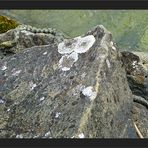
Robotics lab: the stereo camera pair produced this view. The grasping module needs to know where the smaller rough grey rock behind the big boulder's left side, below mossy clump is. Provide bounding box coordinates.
[0,25,64,59]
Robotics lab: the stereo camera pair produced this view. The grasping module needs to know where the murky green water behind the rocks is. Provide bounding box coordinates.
[1,10,148,51]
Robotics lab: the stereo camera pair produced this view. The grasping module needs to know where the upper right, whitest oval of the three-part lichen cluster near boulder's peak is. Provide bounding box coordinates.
[74,35,96,53]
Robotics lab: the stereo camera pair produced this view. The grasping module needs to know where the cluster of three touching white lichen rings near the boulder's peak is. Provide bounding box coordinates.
[58,35,96,71]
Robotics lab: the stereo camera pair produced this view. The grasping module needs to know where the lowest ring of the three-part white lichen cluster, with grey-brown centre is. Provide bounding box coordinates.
[59,52,78,71]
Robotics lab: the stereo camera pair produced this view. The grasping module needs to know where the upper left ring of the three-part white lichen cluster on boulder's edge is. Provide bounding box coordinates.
[58,39,77,54]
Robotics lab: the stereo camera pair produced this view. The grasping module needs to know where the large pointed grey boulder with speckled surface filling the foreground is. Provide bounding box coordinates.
[0,25,137,138]
